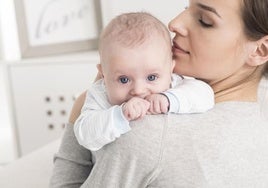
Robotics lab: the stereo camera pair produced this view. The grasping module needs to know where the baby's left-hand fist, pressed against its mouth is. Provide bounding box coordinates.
[123,97,150,121]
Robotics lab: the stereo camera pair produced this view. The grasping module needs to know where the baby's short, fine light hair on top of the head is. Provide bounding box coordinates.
[99,12,171,53]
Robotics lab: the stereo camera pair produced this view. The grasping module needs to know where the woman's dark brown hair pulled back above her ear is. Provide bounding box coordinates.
[242,0,268,75]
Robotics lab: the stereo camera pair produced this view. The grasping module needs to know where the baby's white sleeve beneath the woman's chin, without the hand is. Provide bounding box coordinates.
[163,78,215,113]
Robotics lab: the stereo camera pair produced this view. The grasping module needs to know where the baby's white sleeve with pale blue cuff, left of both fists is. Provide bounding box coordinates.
[74,85,130,151]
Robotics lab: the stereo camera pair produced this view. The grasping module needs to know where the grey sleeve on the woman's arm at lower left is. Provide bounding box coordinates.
[49,124,93,188]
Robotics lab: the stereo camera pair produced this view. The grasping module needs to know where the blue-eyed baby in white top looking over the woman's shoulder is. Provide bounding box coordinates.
[74,12,214,151]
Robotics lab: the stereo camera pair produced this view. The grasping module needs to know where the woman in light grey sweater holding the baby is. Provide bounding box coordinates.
[51,0,268,188]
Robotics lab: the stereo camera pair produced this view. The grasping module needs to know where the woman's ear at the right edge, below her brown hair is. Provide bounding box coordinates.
[248,35,268,66]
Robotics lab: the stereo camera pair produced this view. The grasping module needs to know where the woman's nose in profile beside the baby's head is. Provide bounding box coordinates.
[168,10,188,36]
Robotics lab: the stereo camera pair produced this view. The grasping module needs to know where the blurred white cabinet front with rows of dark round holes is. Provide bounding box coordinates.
[9,62,97,155]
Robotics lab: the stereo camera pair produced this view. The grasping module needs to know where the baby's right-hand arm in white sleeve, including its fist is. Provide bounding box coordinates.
[146,77,214,114]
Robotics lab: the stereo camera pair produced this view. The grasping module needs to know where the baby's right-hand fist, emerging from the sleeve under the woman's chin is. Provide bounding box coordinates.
[145,94,169,114]
